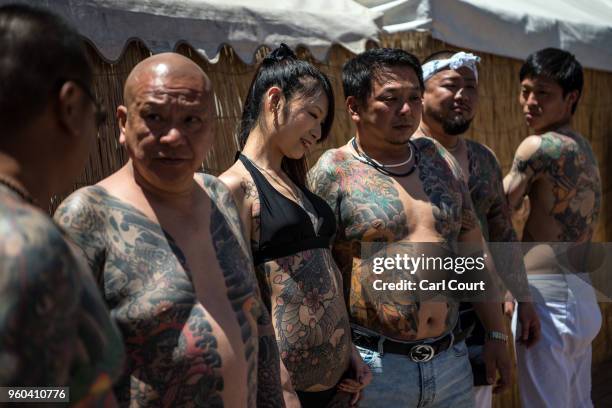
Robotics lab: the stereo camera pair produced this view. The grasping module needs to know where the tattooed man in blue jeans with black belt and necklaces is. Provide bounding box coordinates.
[310,49,510,407]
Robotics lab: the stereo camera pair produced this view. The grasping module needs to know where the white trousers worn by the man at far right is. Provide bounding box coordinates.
[512,274,601,408]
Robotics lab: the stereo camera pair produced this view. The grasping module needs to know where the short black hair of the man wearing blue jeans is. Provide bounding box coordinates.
[342,48,424,103]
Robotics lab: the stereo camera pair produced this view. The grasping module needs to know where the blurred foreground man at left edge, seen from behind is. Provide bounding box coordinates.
[0,6,123,406]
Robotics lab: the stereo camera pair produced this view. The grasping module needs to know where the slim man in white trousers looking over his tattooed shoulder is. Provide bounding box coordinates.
[504,48,601,408]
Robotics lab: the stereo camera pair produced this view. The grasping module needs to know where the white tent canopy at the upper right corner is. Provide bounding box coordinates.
[358,0,612,71]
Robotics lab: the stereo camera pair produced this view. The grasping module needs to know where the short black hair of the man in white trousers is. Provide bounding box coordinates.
[519,48,584,114]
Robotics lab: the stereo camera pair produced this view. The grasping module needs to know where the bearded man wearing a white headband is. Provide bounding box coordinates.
[416,51,540,408]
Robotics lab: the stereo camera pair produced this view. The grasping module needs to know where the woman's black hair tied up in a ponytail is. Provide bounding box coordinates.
[238,44,335,186]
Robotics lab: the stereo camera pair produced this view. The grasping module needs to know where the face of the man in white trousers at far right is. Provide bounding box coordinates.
[519,77,579,135]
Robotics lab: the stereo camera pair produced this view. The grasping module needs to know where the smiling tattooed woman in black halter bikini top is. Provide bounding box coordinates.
[220,44,371,408]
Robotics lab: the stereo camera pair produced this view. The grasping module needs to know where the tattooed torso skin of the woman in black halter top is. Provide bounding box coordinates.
[242,175,351,391]
